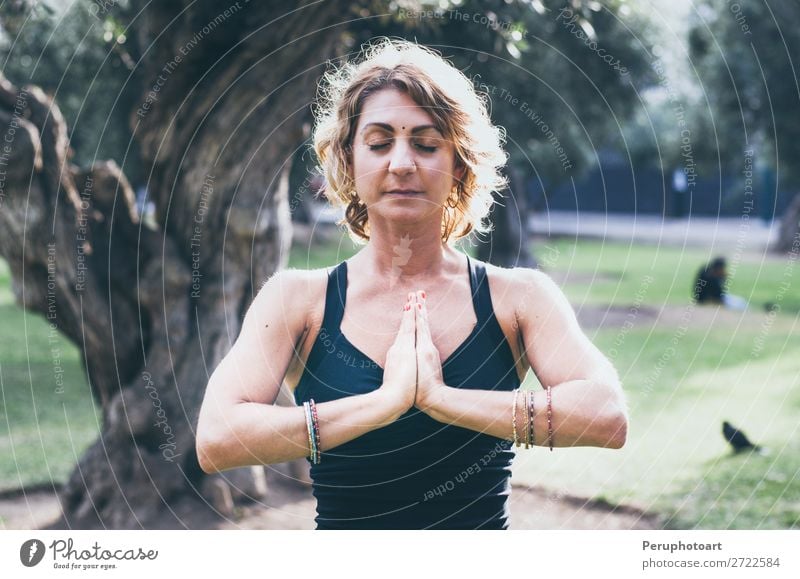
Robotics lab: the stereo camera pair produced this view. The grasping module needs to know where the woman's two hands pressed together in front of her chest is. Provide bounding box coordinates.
[381,291,446,411]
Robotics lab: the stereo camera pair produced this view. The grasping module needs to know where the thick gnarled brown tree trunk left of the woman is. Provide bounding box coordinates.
[0,0,346,529]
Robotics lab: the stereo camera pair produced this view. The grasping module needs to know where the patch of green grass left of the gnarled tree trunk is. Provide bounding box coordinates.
[0,260,100,490]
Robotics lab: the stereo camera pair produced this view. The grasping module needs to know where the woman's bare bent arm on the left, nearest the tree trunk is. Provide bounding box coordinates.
[197,271,414,473]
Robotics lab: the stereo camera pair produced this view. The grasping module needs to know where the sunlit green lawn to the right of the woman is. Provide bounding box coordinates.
[514,241,800,529]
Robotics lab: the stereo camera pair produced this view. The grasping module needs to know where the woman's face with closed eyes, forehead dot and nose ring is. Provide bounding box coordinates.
[351,89,463,223]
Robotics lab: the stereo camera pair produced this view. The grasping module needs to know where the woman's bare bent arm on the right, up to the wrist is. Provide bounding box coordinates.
[417,270,628,448]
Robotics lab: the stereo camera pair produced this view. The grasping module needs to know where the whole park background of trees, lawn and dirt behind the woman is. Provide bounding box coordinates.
[0,0,800,529]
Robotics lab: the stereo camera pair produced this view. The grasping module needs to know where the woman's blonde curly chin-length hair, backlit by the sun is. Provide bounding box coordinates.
[314,38,507,244]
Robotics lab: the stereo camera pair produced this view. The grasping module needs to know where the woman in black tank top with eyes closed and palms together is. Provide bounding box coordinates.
[197,41,627,529]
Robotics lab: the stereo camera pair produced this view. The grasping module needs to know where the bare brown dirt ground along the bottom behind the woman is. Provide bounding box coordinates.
[0,481,661,530]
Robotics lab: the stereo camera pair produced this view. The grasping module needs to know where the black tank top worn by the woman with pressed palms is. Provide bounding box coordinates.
[294,256,520,529]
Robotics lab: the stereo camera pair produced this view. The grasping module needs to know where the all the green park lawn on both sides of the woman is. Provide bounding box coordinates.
[0,232,800,529]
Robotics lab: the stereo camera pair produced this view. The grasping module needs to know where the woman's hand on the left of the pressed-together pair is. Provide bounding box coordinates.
[380,293,417,417]
